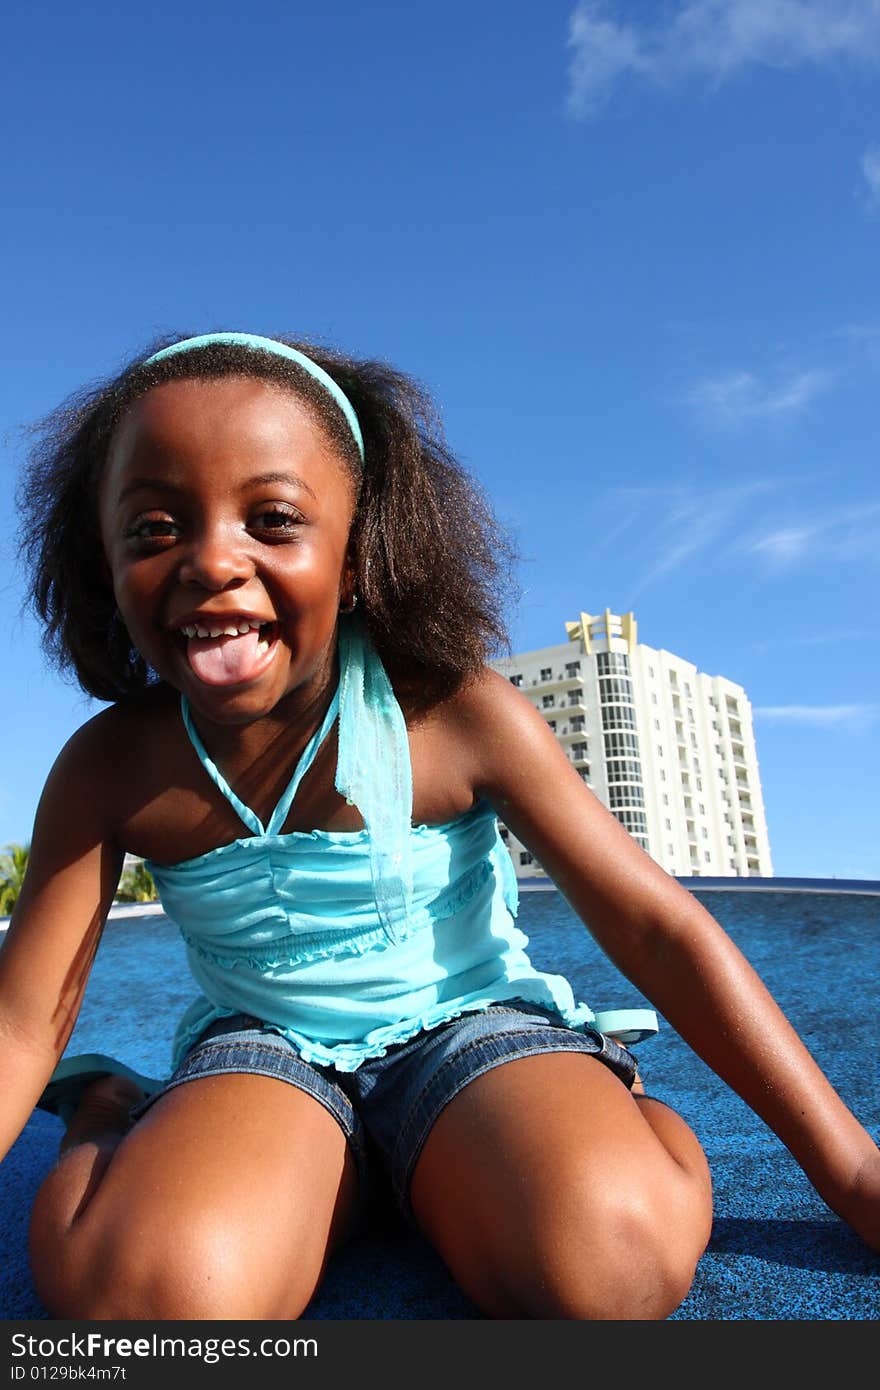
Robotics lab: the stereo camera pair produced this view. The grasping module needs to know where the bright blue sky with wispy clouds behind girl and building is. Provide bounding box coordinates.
[0,0,880,878]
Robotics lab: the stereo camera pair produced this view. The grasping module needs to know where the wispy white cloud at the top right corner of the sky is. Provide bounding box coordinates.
[569,0,880,117]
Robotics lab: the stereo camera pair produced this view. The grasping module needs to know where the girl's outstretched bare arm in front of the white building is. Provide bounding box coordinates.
[459,673,880,1250]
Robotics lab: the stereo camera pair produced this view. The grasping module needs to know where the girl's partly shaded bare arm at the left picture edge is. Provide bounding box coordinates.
[0,714,124,1158]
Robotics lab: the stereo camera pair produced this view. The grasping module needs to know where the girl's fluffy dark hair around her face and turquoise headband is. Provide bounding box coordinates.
[18,334,514,709]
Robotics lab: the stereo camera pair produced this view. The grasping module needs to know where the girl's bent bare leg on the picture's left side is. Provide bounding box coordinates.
[31,1073,357,1319]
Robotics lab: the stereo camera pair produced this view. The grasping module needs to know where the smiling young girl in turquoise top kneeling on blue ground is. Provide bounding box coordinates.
[0,334,880,1319]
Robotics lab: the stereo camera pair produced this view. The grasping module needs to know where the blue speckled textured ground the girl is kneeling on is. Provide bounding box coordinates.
[0,890,880,1321]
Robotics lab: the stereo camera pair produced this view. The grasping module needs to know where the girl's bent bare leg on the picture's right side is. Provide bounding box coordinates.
[410,1052,712,1319]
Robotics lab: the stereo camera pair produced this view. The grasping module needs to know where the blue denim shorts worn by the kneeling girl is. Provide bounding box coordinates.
[133,1001,635,1219]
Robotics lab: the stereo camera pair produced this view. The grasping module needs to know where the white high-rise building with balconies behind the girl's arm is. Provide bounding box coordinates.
[492,609,773,877]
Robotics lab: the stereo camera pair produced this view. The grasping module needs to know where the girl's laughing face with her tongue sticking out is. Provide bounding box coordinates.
[100,377,355,724]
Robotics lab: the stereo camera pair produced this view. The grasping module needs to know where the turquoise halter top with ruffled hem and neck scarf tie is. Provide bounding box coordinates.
[149,621,647,1072]
